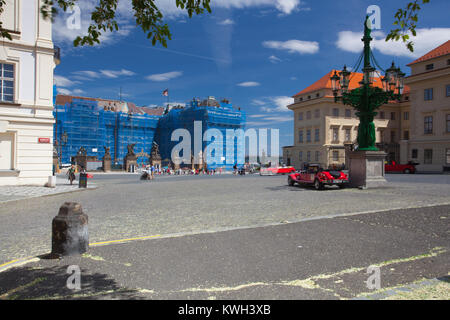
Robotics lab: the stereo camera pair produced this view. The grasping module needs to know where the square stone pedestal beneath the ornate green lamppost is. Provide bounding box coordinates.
[349,150,387,189]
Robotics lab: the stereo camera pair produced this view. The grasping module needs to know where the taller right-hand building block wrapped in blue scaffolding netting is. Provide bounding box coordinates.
[156,97,246,170]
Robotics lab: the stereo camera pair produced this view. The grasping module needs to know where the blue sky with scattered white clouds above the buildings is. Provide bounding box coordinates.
[53,0,450,146]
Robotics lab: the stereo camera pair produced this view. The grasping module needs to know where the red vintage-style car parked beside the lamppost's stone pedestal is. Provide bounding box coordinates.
[288,165,349,190]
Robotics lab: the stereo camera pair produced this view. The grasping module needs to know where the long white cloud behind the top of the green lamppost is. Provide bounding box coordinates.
[336,28,450,58]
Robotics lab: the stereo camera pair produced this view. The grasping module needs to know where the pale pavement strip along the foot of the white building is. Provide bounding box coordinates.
[0,178,95,203]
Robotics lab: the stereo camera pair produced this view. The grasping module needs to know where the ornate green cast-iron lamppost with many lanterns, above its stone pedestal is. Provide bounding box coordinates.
[330,16,405,151]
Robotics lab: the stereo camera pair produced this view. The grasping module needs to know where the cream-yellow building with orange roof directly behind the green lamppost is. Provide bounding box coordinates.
[283,70,410,169]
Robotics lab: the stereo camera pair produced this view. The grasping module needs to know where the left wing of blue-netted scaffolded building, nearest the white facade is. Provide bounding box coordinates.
[54,95,164,164]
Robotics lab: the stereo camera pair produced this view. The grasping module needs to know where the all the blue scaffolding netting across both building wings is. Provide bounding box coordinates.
[54,97,250,170]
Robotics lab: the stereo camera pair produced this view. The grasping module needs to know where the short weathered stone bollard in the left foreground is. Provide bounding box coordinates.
[51,202,89,256]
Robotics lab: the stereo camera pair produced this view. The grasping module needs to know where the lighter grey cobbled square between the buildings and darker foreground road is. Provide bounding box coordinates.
[0,174,450,264]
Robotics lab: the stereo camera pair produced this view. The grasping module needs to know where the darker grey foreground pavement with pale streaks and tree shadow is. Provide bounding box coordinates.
[0,205,450,301]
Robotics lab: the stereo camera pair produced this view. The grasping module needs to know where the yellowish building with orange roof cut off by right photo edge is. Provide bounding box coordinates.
[405,40,450,172]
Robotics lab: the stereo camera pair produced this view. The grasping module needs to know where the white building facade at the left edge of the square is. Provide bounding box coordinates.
[0,0,56,185]
